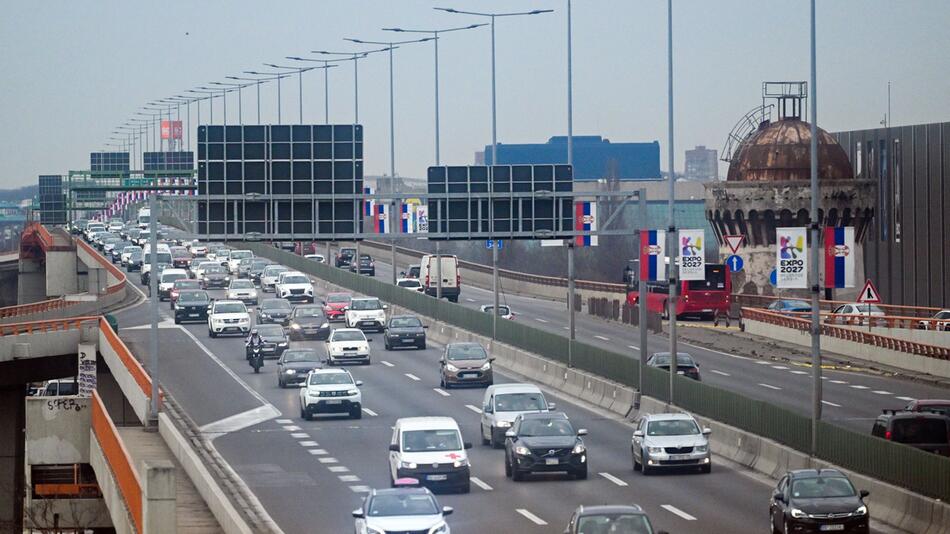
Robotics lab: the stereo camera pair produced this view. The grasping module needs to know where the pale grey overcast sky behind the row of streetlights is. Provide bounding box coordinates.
[0,0,950,188]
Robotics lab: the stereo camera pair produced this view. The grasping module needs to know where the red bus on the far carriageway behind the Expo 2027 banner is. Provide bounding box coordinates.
[624,263,732,319]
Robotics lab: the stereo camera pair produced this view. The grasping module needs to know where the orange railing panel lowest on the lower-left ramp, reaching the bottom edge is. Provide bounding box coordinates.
[92,391,142,532]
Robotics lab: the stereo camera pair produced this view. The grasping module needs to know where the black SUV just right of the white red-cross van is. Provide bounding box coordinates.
[505,412,587,481]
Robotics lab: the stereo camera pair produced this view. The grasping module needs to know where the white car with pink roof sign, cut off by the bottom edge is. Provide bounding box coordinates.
[353,484,453,534]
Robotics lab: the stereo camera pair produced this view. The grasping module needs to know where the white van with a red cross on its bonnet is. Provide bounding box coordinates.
[389,417,472,493]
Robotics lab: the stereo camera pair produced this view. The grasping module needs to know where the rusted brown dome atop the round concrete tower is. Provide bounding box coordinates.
[726,118,854,182]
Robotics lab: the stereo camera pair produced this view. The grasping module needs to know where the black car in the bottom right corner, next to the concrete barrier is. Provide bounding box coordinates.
[769,469,870,534]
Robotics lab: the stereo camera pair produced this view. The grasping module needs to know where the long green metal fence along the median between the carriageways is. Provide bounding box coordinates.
[246,243,950,500]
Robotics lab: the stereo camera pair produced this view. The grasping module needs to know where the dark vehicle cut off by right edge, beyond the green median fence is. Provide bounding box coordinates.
[871,410,950,456]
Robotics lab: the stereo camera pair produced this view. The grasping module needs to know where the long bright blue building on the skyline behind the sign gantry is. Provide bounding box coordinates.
[475,135,660,181]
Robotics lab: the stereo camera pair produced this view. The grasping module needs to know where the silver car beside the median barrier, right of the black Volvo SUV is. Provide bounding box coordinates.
[630,413,712,475]
